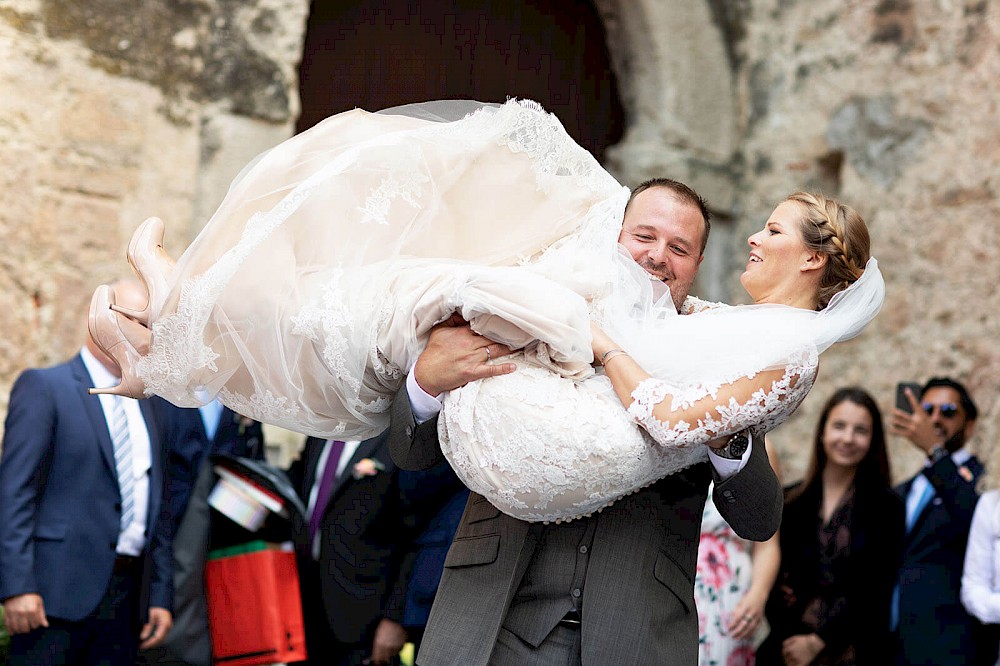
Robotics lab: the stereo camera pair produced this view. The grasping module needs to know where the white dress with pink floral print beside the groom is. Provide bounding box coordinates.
[694,482,754,666]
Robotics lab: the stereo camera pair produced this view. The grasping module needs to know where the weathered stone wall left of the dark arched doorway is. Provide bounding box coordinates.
[0,0,308,462]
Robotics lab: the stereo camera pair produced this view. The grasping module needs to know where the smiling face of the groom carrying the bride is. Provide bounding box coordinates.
[618,187,705,310]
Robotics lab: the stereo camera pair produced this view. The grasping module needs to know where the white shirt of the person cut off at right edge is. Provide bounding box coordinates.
[962,490,1000,632]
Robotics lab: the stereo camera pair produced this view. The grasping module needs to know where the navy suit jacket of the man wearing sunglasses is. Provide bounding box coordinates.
[896,448,983,665]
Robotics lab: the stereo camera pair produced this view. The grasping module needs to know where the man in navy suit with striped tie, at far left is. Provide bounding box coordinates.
[0,282,179,666]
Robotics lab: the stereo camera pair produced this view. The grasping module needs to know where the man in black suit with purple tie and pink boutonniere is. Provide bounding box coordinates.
[289,433,414,666]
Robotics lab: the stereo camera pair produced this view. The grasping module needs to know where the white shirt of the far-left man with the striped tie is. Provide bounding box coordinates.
[80,347,152,556]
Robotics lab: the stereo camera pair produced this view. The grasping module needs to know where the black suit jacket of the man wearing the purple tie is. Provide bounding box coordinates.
[289,433,412,644]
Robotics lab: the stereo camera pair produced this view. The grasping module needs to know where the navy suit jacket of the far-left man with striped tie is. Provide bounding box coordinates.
[0,355,177,621]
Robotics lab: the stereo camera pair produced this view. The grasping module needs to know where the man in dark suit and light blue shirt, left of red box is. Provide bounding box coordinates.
[140,400,264,666]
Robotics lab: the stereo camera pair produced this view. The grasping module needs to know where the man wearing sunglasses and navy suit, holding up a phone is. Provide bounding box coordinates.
[890,377,996,665]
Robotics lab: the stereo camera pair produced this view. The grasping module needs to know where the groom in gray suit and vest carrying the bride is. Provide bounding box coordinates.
[389,179,782,666]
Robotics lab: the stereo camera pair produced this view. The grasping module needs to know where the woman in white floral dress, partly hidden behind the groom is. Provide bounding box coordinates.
[694,447,781,666]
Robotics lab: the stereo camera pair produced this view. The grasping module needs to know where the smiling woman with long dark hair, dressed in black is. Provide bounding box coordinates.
[757,388,904,666]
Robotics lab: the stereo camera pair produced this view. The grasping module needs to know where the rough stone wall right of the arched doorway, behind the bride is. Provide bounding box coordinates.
[730,0,1000,478]
